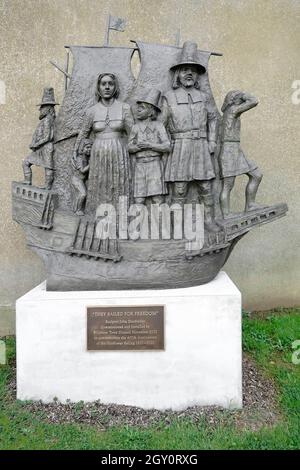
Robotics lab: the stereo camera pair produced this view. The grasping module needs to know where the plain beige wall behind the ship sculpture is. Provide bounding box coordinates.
[0,0,300,330]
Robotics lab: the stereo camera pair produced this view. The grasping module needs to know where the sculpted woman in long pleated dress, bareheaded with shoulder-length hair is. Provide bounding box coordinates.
[73,73,133,213]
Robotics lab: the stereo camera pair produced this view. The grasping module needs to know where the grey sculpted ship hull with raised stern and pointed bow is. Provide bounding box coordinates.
[12,183,287,291]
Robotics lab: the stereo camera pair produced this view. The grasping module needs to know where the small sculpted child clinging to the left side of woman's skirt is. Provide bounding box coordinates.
[71,139,92,215]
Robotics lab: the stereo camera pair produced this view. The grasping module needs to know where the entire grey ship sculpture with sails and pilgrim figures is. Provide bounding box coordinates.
[12,24,287,291]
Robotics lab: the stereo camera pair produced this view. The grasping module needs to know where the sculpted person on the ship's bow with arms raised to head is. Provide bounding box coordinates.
[219,91,263,218]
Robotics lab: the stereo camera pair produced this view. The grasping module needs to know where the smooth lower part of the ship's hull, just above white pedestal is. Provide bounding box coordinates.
[34,242,234,291]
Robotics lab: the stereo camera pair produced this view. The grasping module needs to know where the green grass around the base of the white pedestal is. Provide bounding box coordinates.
[0,309,300,450]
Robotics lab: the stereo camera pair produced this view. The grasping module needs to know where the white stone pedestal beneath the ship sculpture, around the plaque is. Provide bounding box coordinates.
[16,272,242,410]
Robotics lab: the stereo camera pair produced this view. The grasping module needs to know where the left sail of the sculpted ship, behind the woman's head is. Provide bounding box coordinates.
[54,46,135,142]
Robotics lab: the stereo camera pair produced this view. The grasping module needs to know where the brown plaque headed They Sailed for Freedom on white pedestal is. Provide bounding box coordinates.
[87,305,164,351]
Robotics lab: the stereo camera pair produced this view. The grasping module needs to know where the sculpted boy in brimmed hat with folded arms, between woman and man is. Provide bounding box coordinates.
[128,90,171,204]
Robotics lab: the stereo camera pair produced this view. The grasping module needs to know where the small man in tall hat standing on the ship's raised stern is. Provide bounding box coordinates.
[23,88,58,189]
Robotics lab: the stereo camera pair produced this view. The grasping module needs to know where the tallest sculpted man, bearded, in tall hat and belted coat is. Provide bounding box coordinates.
[162,41,219,232]
